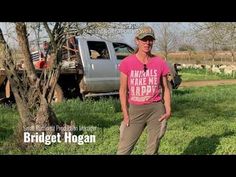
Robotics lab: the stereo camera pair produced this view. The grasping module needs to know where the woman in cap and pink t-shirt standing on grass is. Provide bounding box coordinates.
[117,26,171,154]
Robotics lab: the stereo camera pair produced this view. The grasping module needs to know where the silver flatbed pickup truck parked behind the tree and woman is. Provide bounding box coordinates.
[0,37,181,102]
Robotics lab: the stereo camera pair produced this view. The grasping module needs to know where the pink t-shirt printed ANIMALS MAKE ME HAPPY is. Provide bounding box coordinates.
[119,55,170,105]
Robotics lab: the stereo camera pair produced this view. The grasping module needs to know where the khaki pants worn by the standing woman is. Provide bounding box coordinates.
[117,102,167,155]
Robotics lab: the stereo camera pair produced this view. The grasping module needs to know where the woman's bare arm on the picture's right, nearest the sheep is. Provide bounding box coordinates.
[159,76,171,121]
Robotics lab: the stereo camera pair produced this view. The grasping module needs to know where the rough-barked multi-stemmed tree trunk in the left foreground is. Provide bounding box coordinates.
[0,23,65,148]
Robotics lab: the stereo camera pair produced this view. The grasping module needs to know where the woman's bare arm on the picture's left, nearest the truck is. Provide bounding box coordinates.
[119,72,129,126]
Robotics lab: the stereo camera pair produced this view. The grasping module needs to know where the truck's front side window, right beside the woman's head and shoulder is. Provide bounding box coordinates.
[113,42,134,60]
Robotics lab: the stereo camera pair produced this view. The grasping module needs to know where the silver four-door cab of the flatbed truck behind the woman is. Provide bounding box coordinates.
[77,38,134,94]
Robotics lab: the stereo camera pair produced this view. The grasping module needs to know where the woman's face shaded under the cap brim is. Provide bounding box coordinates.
[136,36,154,53]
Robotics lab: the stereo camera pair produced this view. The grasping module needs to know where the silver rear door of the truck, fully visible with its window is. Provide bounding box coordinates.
[85,41,117,92]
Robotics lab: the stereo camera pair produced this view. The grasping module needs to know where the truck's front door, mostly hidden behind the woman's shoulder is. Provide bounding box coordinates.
[112,42,134,89]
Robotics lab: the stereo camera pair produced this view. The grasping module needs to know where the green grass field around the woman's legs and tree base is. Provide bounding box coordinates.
[0,85,236,155]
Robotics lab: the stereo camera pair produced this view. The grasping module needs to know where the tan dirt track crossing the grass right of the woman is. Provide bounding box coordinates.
[179,79,236,88]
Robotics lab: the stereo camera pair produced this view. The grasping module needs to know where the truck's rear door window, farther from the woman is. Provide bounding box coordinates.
[87,41,110,60]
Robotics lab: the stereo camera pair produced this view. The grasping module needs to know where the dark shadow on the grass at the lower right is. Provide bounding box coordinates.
[182,131,234,155]
